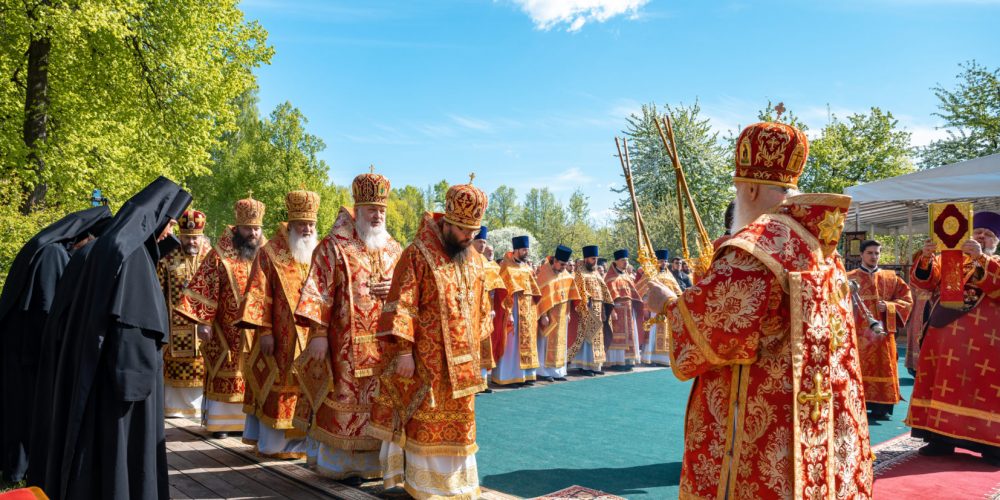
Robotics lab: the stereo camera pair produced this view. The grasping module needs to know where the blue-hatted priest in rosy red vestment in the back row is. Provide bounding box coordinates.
[604,249,644,370]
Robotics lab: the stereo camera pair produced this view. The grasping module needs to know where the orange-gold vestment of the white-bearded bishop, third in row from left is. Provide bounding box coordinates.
[237,222,309,437]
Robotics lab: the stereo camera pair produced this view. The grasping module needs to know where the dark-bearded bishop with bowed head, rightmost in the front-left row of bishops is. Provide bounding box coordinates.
[368,178,491,499]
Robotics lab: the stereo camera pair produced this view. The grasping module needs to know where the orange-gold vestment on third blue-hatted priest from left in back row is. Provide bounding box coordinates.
[537,264,580,368]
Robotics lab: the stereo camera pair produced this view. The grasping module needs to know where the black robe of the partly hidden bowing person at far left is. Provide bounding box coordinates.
[0,207,111,482]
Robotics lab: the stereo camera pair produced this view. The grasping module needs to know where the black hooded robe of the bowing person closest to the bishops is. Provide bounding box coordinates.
[39,177,191,499]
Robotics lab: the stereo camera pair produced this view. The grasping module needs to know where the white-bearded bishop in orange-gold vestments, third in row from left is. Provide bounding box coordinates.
[237,190,320,459]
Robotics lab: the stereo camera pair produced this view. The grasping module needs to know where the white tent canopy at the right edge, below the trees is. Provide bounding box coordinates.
[844,154,1000,234]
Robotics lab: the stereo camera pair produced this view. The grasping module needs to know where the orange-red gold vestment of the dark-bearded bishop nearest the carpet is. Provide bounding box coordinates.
[368,213,491,457]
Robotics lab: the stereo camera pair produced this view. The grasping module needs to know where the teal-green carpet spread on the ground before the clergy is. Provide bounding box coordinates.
[476,363,913,499]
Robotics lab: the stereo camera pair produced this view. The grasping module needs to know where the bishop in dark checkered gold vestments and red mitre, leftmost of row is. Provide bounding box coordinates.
[156,209,212,418]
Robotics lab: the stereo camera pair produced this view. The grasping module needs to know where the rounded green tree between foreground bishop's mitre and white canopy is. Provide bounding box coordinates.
[799,107,914,193]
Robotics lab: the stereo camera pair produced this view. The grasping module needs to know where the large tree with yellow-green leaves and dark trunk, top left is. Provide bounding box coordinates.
[0,0,272,214]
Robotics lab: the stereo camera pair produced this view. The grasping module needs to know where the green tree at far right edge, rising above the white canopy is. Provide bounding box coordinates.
[920,61,1000,168]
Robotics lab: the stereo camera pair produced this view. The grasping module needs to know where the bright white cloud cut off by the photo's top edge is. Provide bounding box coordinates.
[513,0,649,33]
